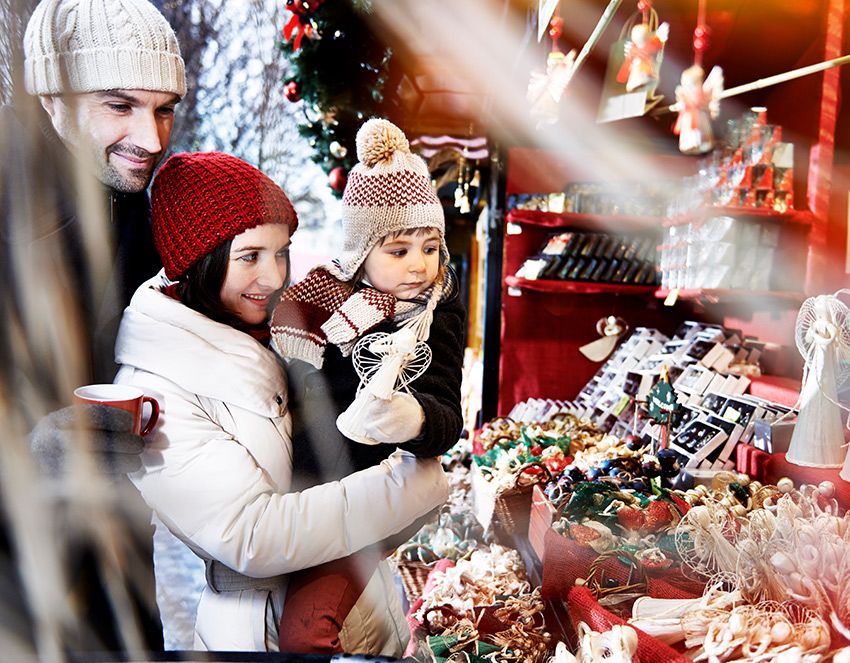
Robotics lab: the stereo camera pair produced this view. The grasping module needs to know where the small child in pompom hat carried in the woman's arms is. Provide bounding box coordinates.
[271,119,465,653]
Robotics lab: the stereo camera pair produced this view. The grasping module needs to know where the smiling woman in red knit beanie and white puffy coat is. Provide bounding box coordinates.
[116,153,448,655]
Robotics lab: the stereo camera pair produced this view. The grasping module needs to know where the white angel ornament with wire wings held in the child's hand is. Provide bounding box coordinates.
[336,326,431,444]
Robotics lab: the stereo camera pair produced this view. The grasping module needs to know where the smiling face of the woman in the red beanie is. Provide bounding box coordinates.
[221,223,289,325]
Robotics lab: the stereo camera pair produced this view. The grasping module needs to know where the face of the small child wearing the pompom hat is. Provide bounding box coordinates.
[363,228,440,299]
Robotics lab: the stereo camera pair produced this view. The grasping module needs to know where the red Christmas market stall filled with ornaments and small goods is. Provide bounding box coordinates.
[372,0,850,663]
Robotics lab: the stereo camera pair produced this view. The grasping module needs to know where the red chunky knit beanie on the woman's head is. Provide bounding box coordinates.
[151,152,298,280]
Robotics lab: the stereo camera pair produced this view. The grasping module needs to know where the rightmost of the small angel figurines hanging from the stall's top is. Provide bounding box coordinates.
[670,64,723,154]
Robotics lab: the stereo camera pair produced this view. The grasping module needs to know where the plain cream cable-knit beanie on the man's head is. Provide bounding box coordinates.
[24,0,186,97]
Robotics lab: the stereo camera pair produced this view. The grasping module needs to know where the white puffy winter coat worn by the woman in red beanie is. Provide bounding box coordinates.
[116,276,448,655]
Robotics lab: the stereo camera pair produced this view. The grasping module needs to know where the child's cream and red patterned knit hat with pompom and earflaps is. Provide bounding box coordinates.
[328,118,449,281]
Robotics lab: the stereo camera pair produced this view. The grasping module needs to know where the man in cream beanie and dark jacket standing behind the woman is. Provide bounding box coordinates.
[0,0,186,659]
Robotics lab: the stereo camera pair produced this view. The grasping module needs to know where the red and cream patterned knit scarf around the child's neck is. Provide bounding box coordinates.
[271,268,443,368]
